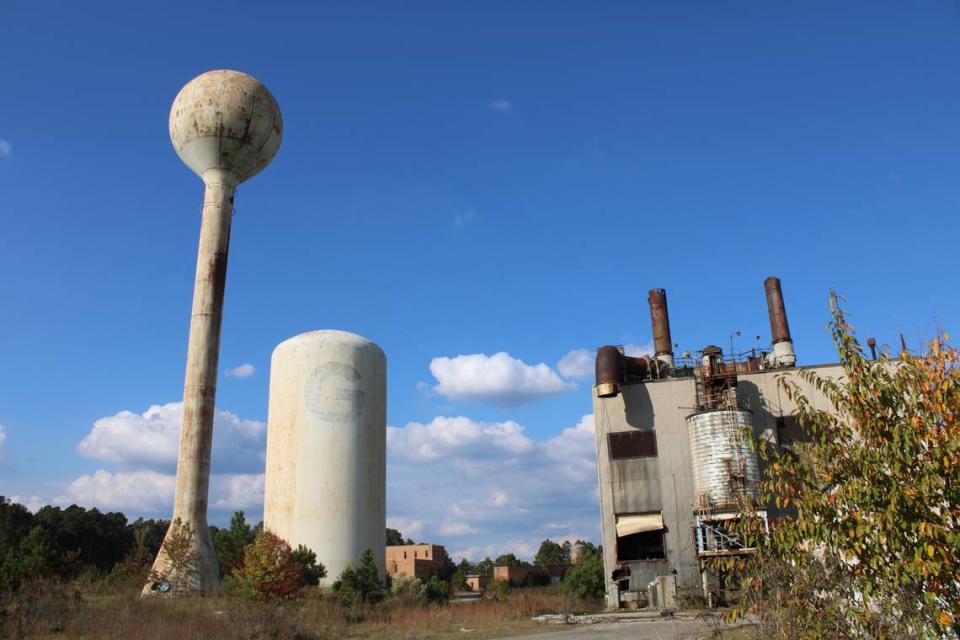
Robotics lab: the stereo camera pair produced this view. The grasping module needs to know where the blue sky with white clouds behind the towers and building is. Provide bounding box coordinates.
[0,0,960,559]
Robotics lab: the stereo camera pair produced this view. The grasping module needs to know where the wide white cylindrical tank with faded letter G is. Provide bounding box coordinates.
[263,331,387,583]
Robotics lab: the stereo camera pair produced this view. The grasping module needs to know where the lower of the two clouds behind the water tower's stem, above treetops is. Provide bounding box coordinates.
[53,469,263,515]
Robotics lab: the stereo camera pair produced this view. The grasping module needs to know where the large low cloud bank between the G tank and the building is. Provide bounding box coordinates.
[387,415,599,560]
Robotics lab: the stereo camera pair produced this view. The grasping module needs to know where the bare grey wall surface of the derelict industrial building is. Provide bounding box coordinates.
[593,365,842,607]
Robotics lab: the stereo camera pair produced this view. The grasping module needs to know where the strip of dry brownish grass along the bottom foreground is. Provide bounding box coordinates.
[0,583,591,640]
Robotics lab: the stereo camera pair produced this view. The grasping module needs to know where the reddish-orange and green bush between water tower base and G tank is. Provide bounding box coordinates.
[227,531,306,601]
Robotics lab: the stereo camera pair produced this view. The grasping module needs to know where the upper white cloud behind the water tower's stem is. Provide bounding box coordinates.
[77,402,267,473]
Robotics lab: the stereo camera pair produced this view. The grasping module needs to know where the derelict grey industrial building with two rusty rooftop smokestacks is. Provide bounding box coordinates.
[593,277,842,608]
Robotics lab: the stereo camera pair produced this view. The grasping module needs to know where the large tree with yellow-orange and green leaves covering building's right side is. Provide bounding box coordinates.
[719,297,960,637]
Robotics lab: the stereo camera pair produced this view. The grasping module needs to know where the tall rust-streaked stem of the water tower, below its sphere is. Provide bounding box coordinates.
[148,173,235,595]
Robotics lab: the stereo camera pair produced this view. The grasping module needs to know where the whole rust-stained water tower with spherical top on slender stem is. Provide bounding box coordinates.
[143,70,283,595]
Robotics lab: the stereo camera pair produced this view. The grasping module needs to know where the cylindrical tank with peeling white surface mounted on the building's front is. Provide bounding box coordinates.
[687,409,760,511]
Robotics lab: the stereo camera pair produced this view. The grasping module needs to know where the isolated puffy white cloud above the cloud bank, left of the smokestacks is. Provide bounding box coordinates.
[430,351,575,407]
